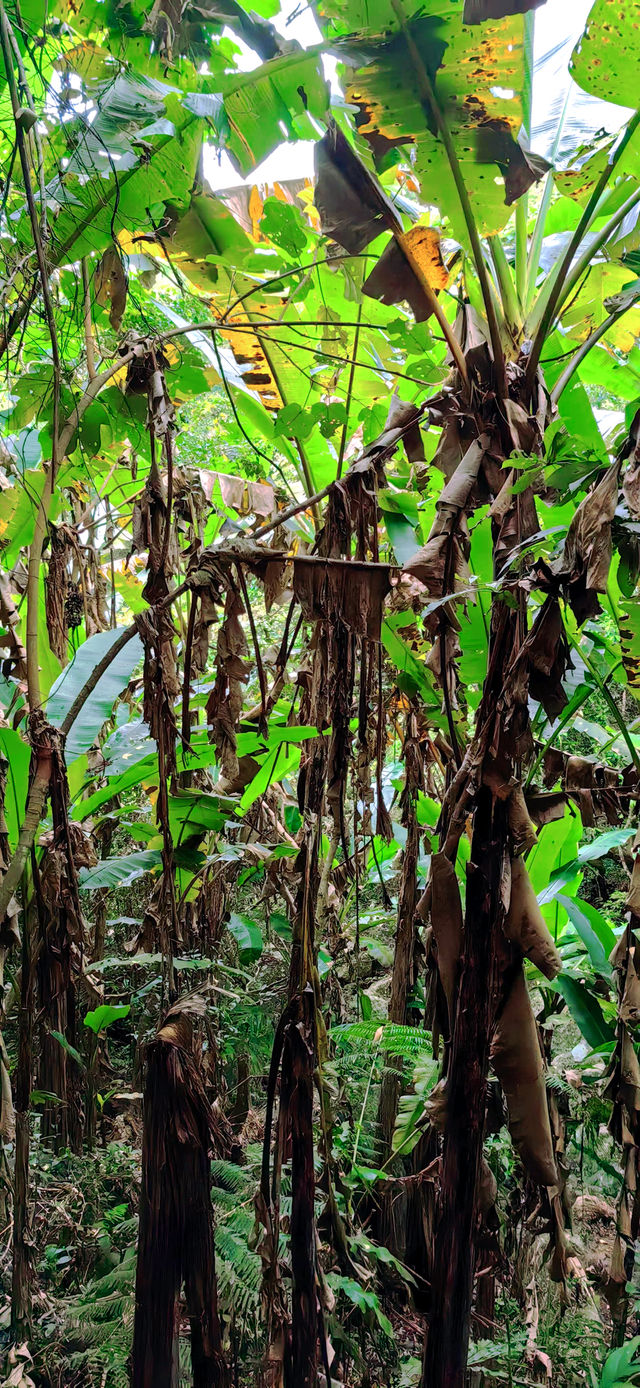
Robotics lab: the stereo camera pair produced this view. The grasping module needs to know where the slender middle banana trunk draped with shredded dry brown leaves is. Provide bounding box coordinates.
[252,444,390,1388]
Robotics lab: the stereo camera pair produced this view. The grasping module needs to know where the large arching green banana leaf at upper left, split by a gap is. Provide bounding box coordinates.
[10,50,328,265]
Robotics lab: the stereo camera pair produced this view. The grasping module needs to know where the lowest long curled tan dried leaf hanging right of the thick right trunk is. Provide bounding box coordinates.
[491,967,558,1185]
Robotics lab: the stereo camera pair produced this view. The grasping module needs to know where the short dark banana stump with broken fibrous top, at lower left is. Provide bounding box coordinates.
[132,999,229,1388]
